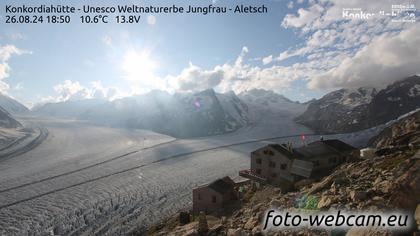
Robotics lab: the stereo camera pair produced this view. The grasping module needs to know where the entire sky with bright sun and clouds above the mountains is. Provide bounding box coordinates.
[0,0,420,107]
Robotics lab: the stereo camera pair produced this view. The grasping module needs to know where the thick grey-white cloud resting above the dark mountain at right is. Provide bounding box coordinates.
[308,24,420,88]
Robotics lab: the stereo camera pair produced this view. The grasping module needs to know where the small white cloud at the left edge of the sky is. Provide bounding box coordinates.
[0,45,31,93]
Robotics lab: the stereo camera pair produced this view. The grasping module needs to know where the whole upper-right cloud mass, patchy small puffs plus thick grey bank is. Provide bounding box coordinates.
[270,0,420,89]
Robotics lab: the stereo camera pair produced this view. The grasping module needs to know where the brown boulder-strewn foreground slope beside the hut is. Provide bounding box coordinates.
[148,113,420,236]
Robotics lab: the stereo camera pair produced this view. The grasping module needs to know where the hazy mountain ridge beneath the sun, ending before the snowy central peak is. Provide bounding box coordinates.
[35,89,248,137]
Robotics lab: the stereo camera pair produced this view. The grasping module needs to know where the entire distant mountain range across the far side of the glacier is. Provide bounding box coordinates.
[0,76,420,138]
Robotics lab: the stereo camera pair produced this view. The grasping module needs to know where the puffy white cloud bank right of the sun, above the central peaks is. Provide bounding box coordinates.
[166,47,300,93]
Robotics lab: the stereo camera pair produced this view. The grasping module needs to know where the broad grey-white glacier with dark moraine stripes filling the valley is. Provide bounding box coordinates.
[0,113,380,235]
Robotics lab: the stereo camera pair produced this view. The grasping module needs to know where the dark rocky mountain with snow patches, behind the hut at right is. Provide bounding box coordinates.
[296,76,420,133]
